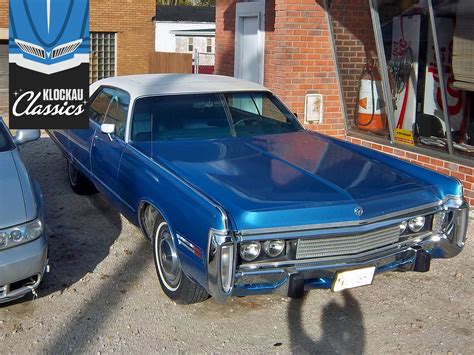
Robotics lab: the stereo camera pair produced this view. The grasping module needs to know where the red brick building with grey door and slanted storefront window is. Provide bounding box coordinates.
[216,0,474,206]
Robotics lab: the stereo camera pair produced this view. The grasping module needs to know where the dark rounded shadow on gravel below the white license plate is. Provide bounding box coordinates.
[287,290,365,354]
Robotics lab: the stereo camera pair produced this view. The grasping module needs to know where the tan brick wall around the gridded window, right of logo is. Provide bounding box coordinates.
[90,0,156,75]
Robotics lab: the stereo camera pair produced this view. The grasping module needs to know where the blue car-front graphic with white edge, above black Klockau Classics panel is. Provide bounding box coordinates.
[9,0,89,74]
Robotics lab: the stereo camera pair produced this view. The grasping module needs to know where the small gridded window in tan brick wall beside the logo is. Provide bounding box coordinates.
[89,32,116,83]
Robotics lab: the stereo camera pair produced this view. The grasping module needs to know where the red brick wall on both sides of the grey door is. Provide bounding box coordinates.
[216,0,344,138]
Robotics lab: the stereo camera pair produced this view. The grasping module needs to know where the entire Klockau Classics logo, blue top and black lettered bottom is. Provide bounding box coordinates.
[9,0,89,129]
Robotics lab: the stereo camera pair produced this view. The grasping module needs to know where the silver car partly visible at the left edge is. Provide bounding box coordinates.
[0,117,48,303]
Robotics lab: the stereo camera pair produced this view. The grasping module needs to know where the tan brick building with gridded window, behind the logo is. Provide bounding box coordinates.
[0,0,156,115]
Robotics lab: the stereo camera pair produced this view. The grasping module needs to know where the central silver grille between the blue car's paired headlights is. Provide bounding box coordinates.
[296,226,400,259]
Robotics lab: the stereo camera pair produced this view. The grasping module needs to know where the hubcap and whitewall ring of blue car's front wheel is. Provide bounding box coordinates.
[155,222,181,291]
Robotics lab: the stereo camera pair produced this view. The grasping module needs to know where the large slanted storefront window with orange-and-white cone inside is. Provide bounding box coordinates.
[329,0,474,163]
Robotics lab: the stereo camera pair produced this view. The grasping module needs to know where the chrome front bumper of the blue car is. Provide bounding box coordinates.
[208,203,469,301]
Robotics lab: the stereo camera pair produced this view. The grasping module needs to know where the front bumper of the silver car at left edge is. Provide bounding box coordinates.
[0,236,48,303]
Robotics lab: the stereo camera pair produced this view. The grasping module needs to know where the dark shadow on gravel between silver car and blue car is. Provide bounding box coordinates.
[21,138,122,297]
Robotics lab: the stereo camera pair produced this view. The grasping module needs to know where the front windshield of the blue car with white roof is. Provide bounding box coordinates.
[131,92,302,142]
